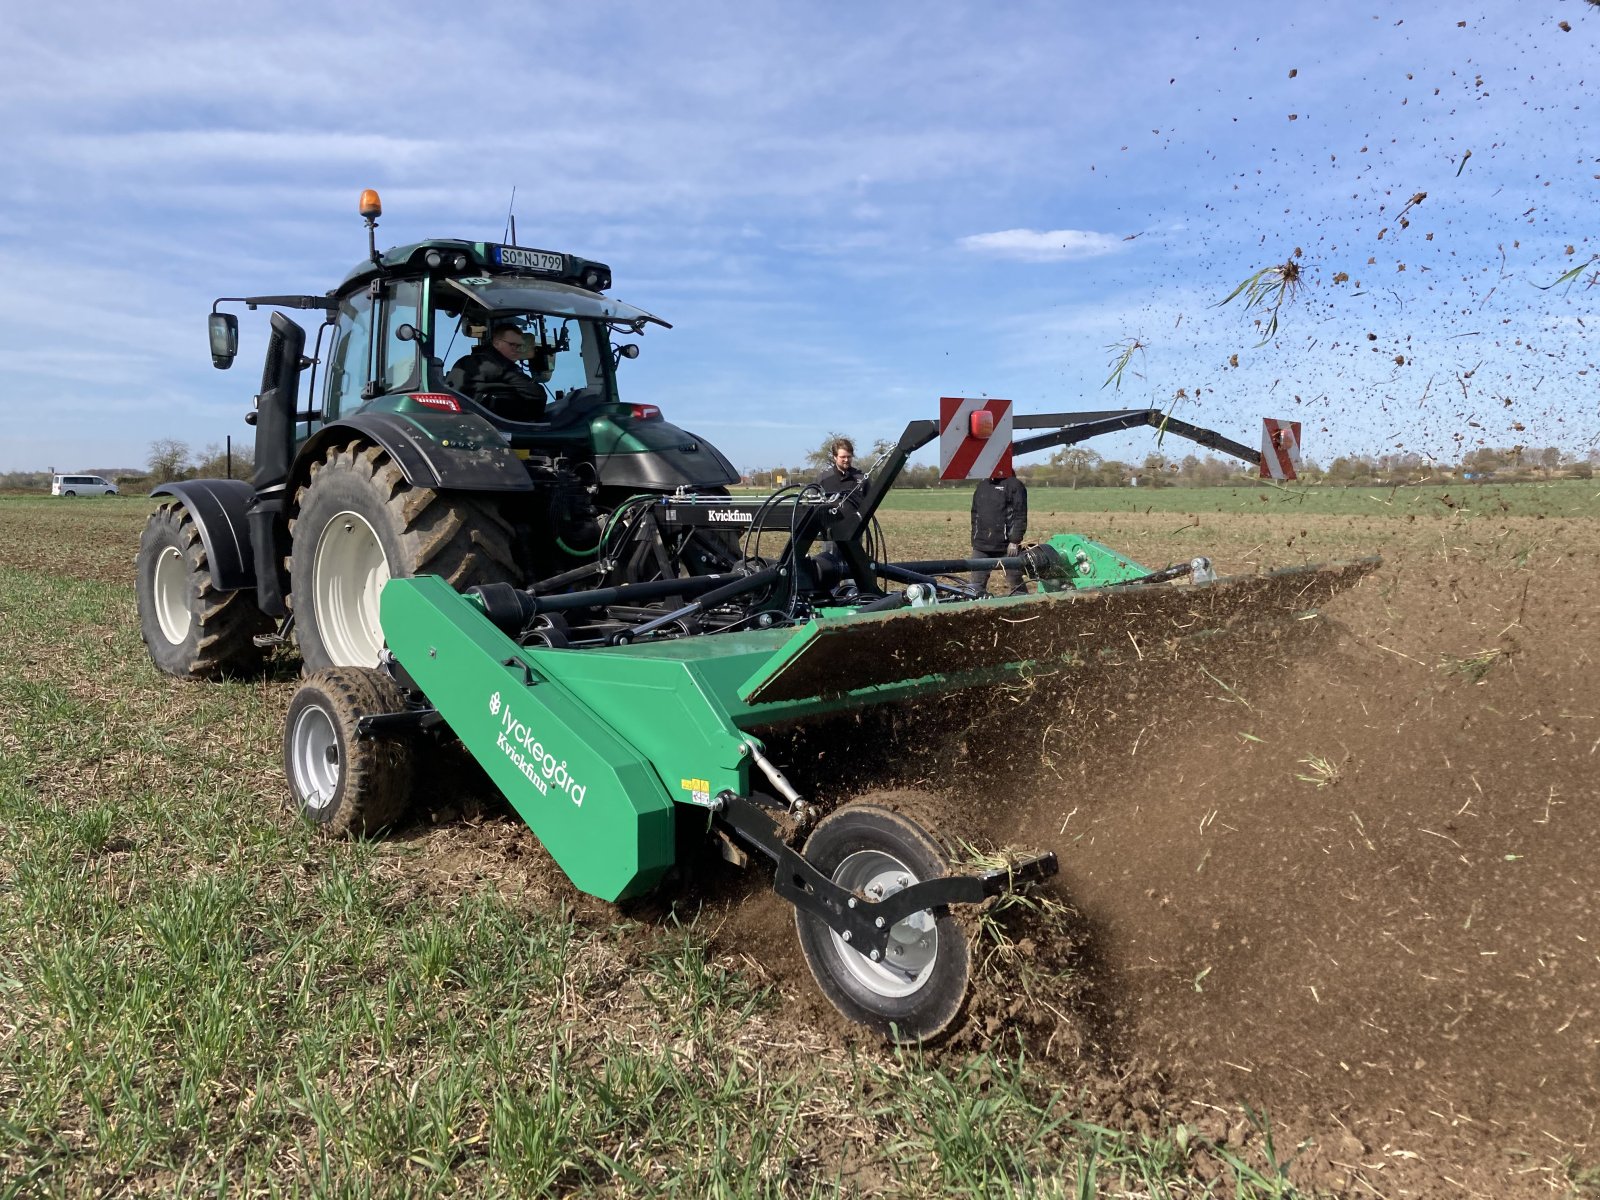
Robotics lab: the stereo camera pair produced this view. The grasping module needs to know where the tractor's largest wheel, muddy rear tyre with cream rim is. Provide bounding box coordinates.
[290,442,522,674]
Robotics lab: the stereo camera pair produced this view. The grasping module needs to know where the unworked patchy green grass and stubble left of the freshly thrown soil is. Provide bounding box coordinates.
[0,493,1584,1200]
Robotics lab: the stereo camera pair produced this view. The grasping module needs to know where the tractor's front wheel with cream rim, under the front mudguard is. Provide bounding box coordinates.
[134,501,272,678]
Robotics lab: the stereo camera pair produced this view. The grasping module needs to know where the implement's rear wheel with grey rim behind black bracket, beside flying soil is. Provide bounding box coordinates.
[795,803,971,1043]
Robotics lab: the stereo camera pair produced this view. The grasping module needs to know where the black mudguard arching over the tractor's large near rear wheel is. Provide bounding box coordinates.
[293,410,533,491]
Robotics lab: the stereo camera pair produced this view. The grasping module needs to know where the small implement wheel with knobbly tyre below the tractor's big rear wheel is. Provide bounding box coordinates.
[283,667,413,837]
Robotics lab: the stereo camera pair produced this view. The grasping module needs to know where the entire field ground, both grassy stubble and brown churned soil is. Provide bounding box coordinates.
[0,482,1600,1197]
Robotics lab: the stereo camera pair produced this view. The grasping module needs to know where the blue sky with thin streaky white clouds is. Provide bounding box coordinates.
[0,0,1600,472]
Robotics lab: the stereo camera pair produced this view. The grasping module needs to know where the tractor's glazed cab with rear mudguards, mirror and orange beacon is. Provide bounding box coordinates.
[211,204,738,505]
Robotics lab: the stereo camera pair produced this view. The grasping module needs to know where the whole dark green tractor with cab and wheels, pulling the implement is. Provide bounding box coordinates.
[138,190,738,678]
